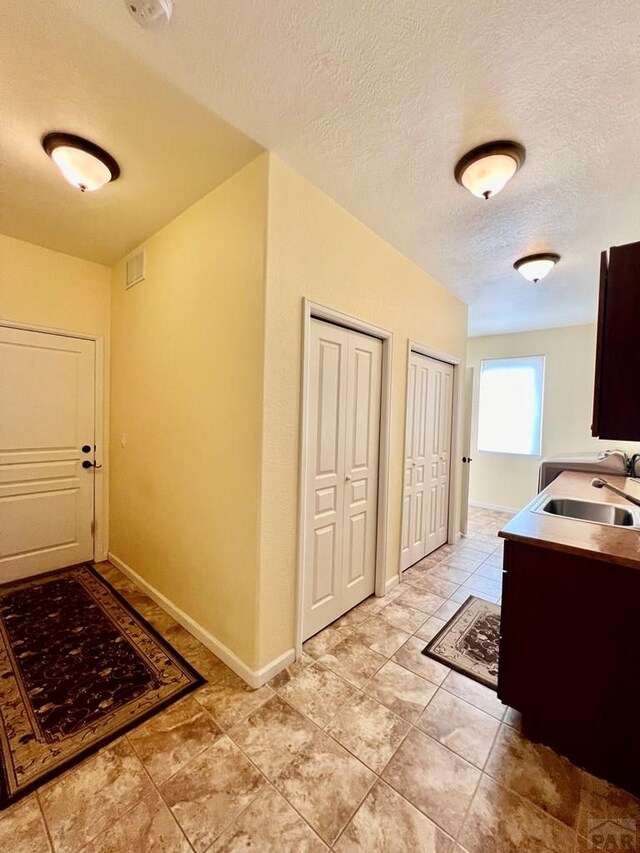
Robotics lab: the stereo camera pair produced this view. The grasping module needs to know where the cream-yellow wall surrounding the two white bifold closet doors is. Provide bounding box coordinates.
[259,154,467,666]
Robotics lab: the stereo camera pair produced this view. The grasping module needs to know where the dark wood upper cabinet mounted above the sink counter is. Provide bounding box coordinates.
[591,243,640,441]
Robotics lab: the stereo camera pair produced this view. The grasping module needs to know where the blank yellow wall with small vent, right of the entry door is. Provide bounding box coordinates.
[110,155,268,669]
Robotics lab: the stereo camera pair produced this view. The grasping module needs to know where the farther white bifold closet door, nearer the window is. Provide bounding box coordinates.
[401,352,453,569]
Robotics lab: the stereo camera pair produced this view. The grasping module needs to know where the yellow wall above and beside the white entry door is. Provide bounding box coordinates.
[0,234,110,559]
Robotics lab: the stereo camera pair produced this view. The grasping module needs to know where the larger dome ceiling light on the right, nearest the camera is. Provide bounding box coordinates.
[454,141,526,199]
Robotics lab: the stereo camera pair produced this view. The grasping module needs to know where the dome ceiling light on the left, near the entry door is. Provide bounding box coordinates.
[42,133,120,192]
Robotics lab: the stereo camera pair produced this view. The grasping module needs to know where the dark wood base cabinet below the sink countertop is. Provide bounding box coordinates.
[498,536,640,795]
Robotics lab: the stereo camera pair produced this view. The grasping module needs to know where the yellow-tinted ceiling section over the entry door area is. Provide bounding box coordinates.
[0,0,261,264]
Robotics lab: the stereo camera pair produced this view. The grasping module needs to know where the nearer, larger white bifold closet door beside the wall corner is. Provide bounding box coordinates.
[303,320,382,639]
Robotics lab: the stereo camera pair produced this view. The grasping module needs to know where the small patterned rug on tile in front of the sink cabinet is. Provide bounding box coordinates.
[422,595,500,690]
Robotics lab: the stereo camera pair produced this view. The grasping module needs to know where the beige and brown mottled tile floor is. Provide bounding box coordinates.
[0,510,640,853]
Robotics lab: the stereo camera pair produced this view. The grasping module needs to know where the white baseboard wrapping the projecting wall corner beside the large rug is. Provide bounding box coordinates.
[107,552,296,688]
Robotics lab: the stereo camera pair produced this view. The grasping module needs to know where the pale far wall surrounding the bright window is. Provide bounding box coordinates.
[467,325,640,508]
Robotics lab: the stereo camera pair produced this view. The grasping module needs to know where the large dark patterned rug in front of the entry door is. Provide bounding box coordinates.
[0,566,204,808]
